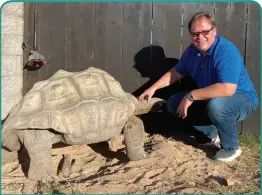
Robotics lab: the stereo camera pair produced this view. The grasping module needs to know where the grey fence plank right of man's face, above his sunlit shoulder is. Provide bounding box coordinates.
[215,2,247,58]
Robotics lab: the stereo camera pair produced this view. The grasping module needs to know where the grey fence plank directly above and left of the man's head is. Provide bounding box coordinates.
[182,3,214,51]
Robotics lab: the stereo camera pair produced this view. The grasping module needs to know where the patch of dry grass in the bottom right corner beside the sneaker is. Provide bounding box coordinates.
[195,133,261,194]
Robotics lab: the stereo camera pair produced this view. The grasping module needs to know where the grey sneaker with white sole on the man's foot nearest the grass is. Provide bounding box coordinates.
[215,147,242,162]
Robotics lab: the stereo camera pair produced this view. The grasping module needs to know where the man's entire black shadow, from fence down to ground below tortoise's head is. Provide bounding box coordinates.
[133,45,210,148]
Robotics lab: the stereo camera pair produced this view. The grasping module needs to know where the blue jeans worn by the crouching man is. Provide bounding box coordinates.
[167,92,257,149]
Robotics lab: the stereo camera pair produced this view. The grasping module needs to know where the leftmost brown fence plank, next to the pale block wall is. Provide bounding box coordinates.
[22,3,38,96]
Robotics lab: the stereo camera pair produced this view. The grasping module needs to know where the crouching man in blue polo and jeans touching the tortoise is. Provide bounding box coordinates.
[139,12,258,162]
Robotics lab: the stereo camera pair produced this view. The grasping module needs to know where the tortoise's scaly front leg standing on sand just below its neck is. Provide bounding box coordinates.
[124,116,145,160]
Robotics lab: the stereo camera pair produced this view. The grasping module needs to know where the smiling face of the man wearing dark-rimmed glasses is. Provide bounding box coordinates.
[190,17,216,54]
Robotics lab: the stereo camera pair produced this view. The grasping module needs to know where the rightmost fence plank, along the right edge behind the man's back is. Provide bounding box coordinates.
[243,3,261,135]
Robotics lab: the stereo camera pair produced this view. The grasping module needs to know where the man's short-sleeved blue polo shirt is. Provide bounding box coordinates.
[175,36,258,105]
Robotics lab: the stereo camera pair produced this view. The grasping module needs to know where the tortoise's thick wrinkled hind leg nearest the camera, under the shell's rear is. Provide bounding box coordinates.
[18,130,55,182]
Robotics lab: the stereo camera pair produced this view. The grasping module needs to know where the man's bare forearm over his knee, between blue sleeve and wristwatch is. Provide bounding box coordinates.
[191,83,237,100]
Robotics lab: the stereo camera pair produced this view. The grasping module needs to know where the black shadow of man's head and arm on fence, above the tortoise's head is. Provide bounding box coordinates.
[132,45,196,100]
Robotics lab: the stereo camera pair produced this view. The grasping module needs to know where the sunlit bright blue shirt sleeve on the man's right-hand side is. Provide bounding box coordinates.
[216,49,243,84]
